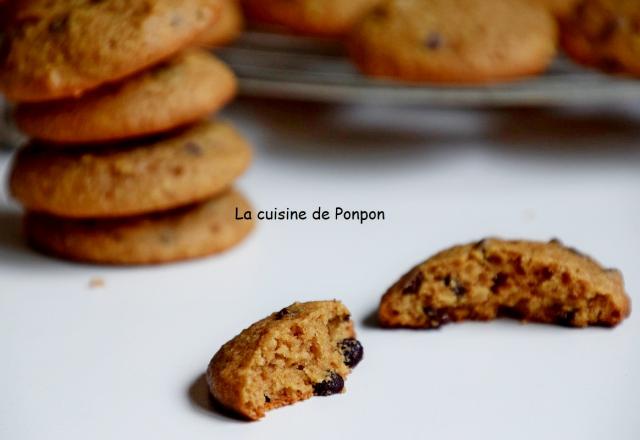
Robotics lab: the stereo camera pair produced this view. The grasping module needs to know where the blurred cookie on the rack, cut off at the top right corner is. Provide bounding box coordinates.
[561,0,640,75]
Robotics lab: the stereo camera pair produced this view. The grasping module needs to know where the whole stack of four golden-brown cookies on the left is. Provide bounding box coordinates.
[0,0,252,264]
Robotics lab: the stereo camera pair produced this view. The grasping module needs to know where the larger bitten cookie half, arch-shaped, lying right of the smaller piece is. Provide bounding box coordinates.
[378,239,631,328]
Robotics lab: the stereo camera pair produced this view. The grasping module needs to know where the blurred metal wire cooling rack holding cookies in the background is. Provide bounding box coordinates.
[217,31,640,106]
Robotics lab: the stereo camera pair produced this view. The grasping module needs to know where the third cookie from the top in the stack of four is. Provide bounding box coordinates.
[10,122,251,218]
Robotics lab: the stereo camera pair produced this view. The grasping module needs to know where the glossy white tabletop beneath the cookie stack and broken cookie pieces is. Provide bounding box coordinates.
[0,100,640,440]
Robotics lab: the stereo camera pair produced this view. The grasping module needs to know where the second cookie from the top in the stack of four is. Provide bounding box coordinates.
[15,49,236,143]
